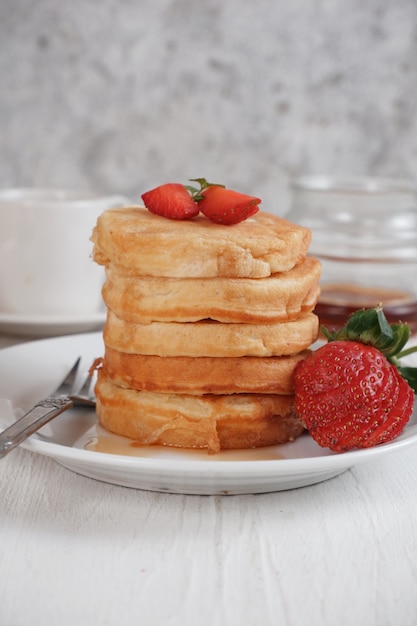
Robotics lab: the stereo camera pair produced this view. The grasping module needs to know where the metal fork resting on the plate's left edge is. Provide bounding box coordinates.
[0,357,96,458]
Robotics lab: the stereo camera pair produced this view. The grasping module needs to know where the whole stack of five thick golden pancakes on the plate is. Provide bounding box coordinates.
[92,206,320,452]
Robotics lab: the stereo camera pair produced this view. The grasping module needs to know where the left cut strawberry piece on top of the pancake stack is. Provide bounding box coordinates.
[142,183,199,220]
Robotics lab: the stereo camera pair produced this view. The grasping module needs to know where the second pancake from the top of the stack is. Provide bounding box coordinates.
[103,257,321,324]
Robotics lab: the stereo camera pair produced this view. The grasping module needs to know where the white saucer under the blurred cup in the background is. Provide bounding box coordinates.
[0,311,106,337]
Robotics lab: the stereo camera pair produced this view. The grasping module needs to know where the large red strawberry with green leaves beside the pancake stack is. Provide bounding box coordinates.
[294,307,417,452]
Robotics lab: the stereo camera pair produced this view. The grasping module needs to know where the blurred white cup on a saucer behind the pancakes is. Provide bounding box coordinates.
[0,188,128,318]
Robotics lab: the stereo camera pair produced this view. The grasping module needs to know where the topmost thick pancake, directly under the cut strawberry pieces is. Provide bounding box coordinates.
[92,206,311,278]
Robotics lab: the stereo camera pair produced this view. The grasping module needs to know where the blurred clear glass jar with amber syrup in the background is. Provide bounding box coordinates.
[286,176,417,330]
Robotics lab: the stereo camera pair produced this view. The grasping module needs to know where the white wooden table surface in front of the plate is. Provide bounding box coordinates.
[0,336,417,626]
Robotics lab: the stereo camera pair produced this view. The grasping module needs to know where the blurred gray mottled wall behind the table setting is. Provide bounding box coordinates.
[0,0,417,213]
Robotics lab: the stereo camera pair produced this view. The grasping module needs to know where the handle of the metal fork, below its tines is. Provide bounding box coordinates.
[0,396,73,458]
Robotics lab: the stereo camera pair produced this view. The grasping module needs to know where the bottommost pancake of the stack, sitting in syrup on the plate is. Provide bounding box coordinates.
[95,369,304,453]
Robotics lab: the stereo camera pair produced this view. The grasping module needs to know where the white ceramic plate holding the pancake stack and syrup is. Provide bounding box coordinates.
[0,333,417,495]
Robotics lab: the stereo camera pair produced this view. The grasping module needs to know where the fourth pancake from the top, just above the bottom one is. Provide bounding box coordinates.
[103,346,309,395]
